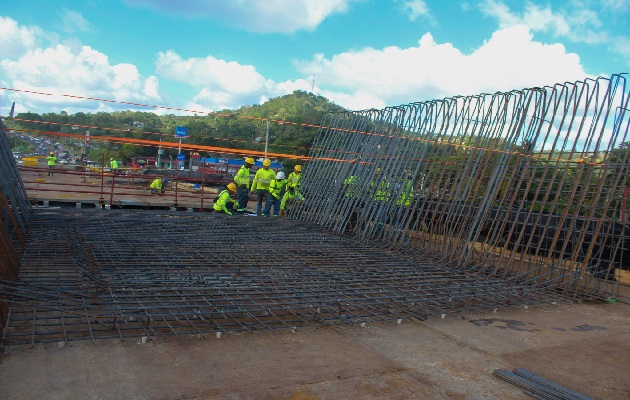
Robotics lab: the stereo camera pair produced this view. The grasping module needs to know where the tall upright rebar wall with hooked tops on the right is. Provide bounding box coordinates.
[296,75,630,297]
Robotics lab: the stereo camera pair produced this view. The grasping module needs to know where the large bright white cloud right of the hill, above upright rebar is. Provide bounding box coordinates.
[295,25,587,109]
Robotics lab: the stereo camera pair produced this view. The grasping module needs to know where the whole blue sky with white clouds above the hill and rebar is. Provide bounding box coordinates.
[0,0,630,116]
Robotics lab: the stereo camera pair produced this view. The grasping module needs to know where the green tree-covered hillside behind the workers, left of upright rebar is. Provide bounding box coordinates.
[7,91,344,161]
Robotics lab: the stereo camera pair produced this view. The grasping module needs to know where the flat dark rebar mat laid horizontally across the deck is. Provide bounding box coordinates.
[0,209,562,345]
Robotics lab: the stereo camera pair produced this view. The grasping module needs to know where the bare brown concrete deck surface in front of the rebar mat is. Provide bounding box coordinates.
[0,302,630,400]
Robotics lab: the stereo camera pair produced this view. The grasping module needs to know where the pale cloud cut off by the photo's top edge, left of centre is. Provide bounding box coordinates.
[125,0,350,33]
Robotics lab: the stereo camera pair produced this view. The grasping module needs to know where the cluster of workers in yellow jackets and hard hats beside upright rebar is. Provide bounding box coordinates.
[214,157,304,217]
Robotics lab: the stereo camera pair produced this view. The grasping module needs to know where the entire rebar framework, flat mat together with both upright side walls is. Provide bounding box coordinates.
[0,75,630,345]
